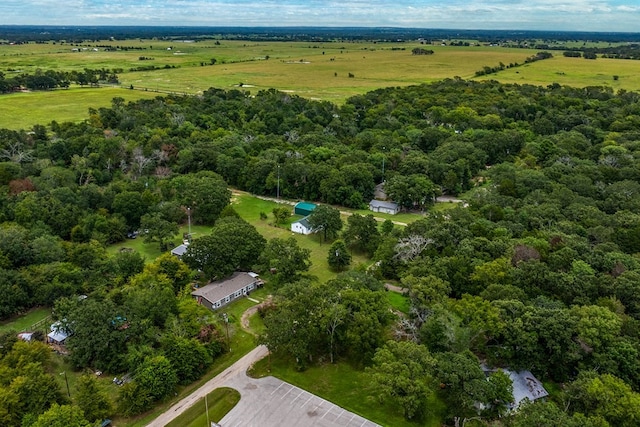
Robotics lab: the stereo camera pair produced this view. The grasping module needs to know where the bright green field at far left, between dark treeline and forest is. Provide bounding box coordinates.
[0,87,158,130]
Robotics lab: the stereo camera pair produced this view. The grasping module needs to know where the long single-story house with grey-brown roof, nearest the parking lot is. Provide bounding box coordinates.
[191,272,264,310]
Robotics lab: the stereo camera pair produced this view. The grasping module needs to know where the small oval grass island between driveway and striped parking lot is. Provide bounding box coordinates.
[167,387,240,427]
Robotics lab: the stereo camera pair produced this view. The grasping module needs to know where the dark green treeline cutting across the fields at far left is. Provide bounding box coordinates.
[0,68,122,93]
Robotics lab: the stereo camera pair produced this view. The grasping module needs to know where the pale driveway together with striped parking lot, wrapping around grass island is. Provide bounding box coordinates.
[148,346,377,427]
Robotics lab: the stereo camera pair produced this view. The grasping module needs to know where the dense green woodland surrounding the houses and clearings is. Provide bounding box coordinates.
[0,79,640,427]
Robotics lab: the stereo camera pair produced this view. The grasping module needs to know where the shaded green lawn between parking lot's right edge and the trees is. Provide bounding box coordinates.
[251,357,443,427]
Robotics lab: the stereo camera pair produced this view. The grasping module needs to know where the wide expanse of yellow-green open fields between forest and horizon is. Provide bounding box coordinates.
[5,40,640,129]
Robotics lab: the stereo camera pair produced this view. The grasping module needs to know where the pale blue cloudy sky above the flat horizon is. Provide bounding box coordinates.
[0,0,640,32]
